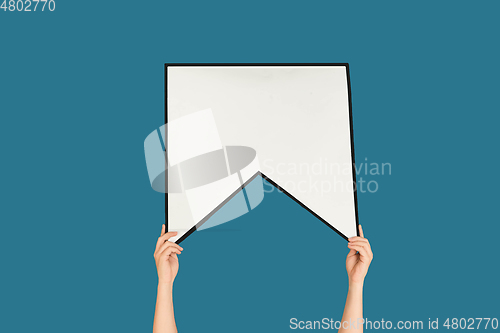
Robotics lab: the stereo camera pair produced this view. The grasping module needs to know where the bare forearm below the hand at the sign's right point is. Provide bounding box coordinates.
[339,283,363,333]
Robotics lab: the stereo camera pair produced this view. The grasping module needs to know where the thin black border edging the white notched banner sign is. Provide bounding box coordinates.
[164,63,359,244]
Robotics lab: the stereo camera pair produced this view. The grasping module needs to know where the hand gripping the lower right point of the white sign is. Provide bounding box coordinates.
[345,225,373,285]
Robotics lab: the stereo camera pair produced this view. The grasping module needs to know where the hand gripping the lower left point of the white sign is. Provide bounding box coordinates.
[154,225,183,285]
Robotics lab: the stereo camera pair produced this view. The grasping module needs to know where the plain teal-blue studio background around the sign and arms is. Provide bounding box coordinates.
[0,0,500,333]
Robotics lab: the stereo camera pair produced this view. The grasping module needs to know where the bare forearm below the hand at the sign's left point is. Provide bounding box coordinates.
[153,283,177,333]
